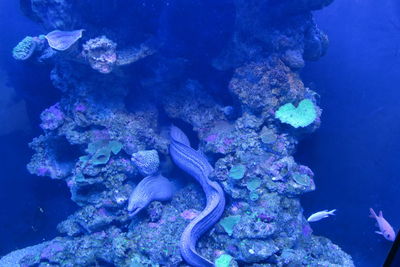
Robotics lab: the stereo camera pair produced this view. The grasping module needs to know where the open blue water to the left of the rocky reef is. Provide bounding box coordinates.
[0,1,75,255]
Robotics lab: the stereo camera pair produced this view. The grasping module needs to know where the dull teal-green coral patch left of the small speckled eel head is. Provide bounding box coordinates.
[79,140,122,165]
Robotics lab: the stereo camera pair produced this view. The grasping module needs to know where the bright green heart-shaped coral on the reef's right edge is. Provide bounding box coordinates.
[275,99,317,128]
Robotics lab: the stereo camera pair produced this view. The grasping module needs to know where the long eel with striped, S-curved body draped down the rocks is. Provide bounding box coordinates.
[169,126,225,267]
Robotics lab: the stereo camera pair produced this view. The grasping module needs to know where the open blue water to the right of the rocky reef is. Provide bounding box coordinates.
[297,0,400,266]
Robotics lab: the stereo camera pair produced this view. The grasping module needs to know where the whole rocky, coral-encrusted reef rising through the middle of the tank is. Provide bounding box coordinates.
[0,0,353,267]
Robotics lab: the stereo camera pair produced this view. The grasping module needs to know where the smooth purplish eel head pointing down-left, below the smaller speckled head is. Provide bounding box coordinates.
[128,174,174,216]
